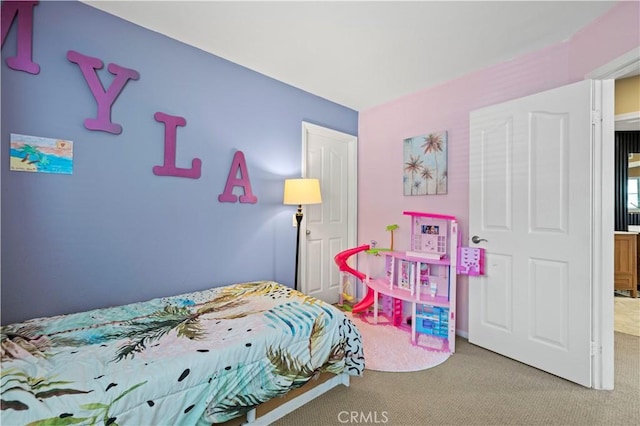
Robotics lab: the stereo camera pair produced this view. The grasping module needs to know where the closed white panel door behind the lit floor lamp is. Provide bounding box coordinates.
[300,123,357,303]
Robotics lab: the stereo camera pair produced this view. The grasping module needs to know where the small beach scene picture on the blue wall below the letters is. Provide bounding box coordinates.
[9,133,73,175]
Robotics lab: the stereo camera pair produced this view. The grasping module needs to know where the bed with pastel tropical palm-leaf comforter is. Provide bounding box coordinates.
[0,281,364,426]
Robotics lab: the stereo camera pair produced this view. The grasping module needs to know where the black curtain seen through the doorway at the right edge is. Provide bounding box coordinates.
[614,131,640,231]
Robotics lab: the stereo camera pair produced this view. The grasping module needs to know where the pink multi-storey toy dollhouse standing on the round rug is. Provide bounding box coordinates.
[365,212,459,352]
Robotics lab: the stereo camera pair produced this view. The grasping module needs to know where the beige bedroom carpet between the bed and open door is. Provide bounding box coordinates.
[274,333,640,426]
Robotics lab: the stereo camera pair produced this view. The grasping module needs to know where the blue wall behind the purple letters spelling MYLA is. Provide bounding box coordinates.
[0,1,358,324]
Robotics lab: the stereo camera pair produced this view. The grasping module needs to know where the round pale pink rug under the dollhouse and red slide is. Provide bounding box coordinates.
[347,312,451,372]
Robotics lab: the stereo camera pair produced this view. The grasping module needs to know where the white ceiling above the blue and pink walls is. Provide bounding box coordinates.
[84,0,615,111]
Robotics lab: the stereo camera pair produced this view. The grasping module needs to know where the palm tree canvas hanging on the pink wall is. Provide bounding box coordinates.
[402,131,448,195]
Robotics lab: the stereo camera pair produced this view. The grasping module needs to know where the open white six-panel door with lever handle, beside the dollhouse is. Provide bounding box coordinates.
[469,80,613,387]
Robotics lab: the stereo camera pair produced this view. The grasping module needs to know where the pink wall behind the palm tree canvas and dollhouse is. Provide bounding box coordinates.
[358,2,640,333]
